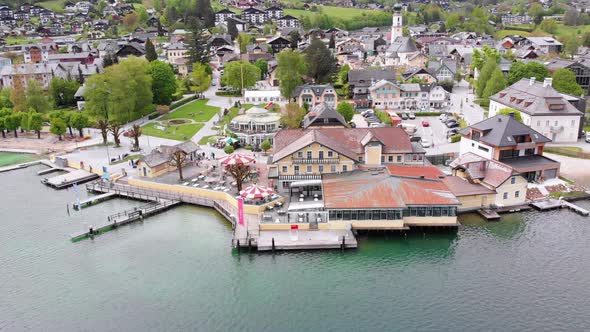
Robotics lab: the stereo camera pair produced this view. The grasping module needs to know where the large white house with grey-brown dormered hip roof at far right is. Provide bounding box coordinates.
[489,77,585,143]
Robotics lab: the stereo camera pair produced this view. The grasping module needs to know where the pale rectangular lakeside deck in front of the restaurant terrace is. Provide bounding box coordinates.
[257,230,358,251]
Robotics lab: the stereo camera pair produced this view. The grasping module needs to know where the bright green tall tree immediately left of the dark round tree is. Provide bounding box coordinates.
[276,49,307,99]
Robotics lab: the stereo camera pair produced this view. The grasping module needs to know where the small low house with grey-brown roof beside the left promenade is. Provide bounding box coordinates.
[137,141,200,178]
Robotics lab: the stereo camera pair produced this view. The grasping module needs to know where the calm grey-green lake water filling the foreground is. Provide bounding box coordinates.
[0,167,590,331]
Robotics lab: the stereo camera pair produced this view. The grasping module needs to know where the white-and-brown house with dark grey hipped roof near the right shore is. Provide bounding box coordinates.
[460,113,560,182]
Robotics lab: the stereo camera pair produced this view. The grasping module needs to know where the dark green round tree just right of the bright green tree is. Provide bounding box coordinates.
[305,39,337,83]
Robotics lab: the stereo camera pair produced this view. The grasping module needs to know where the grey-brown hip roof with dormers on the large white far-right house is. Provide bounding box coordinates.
[490,78,582,116]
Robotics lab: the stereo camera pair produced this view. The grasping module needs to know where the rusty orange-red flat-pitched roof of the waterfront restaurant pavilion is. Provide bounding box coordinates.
[322,169,459,209]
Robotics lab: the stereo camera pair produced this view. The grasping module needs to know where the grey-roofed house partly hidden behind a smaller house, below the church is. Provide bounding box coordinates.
[348,68,397,108]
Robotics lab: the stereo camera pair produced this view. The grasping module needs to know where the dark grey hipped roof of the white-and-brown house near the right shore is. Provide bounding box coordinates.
[461,114,551,147]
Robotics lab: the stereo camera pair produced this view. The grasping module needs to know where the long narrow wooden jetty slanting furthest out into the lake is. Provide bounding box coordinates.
[70,200,180,242]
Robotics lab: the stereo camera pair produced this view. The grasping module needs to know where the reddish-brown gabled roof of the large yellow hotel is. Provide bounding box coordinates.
[273,127,422,162]
